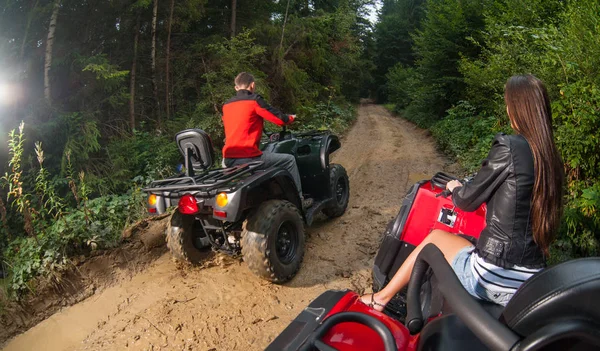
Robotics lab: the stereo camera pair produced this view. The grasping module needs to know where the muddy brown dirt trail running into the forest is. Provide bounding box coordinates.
[5,104,447,351]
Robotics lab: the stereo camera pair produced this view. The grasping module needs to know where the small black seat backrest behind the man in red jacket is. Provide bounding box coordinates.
[175,129,215,169]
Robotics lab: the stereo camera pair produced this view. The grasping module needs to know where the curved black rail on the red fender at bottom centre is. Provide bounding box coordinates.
[298,312,398,351]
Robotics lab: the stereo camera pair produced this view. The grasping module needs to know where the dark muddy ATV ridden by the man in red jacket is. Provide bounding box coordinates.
[144,128,350,283]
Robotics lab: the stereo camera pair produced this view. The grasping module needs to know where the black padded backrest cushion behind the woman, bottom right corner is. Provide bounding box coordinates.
[502,257,600,336]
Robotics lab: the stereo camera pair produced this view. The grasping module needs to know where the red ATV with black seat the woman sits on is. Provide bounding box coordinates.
[267,173,600,351]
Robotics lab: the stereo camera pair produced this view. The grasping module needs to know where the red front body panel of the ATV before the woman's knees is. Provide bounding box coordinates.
[400,182,486,246]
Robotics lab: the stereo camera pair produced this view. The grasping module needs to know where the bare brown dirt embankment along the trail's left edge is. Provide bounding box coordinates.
[0,216,167,345]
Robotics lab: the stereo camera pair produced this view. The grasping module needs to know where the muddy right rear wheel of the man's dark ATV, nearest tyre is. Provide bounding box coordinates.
[241,200,305,284]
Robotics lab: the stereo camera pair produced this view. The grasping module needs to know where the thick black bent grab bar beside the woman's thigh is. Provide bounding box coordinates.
[406,244,519,351]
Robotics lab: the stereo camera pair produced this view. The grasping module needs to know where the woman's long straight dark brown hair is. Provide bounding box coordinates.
[504,75,564,255]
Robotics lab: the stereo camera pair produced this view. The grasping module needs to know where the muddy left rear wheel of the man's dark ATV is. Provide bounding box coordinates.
[166,211,209,264]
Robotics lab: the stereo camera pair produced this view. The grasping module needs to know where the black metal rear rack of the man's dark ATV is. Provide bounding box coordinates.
[143,161,263,192]
